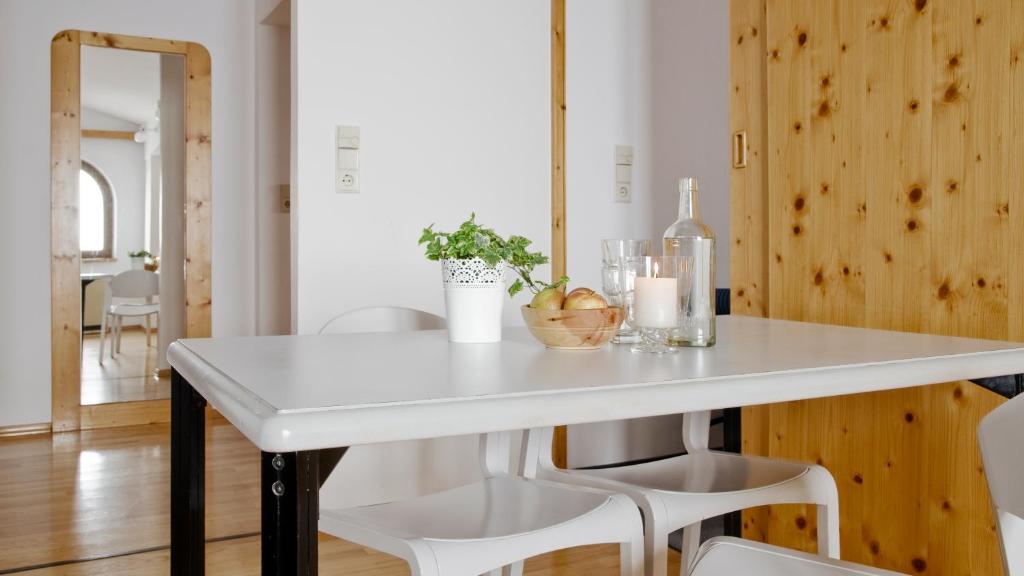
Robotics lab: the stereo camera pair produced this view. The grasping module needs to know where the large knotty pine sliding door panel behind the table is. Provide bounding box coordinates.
[730,0,1024,574]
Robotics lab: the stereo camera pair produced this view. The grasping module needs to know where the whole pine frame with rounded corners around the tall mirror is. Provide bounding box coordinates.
[50,30,212,431]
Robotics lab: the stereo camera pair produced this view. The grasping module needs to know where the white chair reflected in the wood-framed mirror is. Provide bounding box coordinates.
[99,270,160,364]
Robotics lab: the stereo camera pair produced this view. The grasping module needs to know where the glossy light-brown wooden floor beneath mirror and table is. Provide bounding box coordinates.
[0,418,679,576]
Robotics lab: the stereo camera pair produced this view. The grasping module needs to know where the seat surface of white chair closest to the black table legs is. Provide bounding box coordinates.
[321,477,610,540]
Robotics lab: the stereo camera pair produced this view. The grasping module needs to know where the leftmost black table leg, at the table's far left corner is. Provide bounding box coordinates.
[171,369,206,576]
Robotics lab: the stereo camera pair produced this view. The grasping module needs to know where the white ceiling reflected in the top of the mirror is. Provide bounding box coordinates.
[82,46,160,126]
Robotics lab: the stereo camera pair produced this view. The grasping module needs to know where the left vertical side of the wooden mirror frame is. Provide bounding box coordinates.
[50,31,82,431]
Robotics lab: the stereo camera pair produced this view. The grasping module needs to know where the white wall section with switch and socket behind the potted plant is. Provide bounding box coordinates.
[292,0,551,506]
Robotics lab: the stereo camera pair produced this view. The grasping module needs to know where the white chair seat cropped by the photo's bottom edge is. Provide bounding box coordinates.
[689,536,902,576]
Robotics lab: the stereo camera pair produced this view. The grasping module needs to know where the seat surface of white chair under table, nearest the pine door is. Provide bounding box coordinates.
[565,451,808,494]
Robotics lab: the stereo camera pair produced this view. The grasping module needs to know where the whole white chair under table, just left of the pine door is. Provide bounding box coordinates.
[528,412,839,576]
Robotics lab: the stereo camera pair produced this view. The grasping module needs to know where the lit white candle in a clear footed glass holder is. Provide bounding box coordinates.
[633,256,692,354]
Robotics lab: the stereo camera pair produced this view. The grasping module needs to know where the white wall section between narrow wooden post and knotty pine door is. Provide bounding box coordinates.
[565,0,729,466]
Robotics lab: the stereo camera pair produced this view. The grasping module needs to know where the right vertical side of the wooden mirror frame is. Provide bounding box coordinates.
[184,43,213,338]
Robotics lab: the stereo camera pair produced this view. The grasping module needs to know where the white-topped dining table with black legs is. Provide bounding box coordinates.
[167,317,1024,576]
